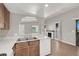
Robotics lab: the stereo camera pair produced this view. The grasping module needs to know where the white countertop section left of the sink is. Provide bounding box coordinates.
[0,37,17,56]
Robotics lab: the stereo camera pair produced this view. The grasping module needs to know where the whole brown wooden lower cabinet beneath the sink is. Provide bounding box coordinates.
[13,40,40,56]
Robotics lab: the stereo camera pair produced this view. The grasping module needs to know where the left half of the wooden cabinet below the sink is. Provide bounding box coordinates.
[15,42,29,56]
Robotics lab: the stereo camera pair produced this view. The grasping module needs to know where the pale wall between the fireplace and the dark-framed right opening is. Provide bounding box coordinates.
[45,8,79,45]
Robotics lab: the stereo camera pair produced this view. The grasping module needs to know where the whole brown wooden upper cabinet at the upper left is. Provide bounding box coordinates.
[0,3,10,30]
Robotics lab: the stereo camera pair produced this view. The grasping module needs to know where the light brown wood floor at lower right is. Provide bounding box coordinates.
[50,40,79,56]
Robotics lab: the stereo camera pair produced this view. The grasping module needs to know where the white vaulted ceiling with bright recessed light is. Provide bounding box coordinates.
[4,3,79,18]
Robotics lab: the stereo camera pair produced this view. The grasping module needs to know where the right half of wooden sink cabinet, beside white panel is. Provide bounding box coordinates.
[29,41,40,56]
